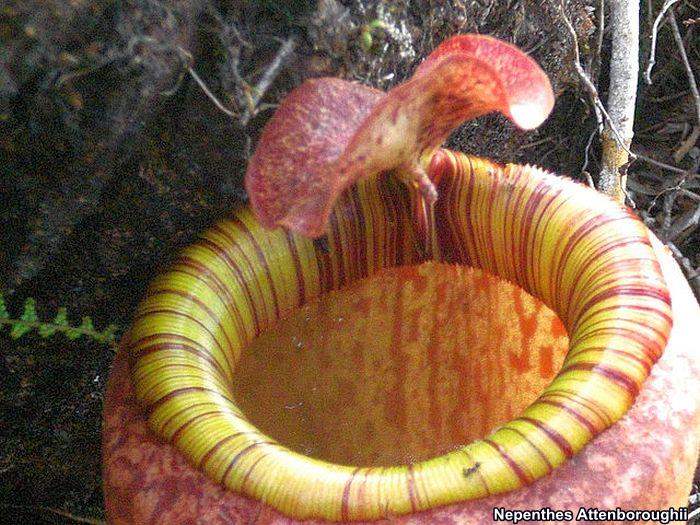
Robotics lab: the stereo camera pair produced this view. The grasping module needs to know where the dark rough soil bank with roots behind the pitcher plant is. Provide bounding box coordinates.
[0,0,700,523]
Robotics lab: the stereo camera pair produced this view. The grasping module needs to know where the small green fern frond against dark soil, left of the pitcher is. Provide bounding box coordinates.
[0,293,117,346]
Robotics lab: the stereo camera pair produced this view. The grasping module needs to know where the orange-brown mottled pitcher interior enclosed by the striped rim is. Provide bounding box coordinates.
[234,263,568,466]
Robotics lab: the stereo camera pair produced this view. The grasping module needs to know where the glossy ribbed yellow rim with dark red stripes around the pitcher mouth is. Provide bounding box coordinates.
[129,153,671,520]
